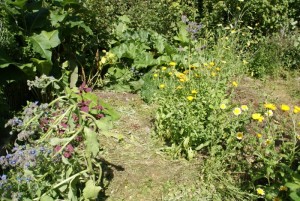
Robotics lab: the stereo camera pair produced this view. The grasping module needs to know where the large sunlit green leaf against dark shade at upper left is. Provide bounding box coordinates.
[29,30,60,62]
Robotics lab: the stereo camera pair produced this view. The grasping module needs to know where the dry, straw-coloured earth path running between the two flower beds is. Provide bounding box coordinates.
[98,92,199,201]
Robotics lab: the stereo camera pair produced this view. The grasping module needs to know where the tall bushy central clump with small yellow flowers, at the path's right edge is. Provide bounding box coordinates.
[141,17,247,158]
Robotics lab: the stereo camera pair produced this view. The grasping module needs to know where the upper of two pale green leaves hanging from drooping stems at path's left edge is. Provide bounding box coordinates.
[84,127,100,156]
